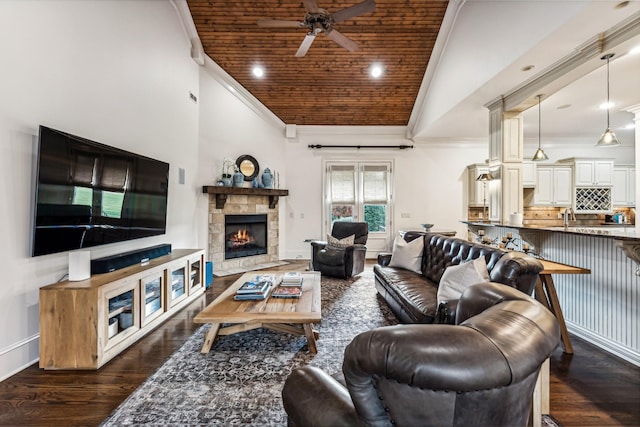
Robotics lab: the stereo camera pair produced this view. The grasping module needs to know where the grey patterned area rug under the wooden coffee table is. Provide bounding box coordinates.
[102,272,559,427]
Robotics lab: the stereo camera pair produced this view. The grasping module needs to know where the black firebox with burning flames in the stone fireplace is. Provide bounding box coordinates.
[224,214,267,259]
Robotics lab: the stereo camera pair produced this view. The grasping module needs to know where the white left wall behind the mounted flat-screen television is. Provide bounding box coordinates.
[0,0,199,379]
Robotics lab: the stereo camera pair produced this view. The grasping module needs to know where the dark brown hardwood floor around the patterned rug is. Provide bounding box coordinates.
[0,261,640,427]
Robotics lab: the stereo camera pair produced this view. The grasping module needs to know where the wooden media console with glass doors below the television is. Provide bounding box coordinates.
[40,249,204,369]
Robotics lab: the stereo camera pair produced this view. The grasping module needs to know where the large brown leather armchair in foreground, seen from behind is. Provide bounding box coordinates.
[282,282,560,427]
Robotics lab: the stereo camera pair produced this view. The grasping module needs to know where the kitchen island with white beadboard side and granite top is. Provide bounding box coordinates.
[462,221,640,366]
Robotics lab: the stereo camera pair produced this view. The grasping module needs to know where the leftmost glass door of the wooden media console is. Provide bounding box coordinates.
[105,283,140,350]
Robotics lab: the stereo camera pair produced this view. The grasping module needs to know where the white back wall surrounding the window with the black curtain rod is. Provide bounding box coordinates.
[281,128,488,259]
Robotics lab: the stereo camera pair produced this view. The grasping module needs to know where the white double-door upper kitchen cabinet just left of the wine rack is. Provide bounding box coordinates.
[534,165,573,207]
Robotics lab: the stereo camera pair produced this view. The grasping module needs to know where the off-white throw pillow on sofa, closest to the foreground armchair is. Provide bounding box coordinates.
[437,257,489,303]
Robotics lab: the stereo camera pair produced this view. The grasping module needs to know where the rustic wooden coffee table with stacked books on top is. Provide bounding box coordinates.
[193,271,322,354]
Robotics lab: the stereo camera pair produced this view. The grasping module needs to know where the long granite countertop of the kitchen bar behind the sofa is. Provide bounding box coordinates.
[460,221,640,240]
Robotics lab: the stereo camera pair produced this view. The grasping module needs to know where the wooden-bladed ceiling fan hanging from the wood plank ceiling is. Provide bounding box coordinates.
[258,0,376,58]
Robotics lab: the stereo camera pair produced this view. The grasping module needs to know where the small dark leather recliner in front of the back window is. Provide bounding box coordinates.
[311,221,369,279]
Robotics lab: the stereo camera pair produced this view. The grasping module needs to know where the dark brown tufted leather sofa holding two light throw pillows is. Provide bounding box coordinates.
[373,232,543,323]
